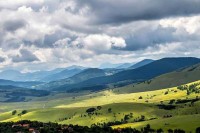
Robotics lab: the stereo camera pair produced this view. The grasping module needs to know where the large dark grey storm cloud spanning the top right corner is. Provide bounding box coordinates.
[77,0,200,24]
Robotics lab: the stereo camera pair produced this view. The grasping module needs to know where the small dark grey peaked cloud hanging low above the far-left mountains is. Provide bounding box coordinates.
[12,49,39,62]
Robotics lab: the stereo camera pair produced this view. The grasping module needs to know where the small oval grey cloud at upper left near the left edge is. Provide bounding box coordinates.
[3,20,26,32]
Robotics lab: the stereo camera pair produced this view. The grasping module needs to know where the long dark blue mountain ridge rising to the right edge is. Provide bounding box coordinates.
[51,57,200,90]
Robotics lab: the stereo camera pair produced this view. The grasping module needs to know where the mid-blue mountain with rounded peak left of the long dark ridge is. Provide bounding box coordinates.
[37,68,106,89]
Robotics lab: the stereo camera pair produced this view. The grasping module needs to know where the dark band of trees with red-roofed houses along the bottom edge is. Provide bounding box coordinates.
[0,120,197,133]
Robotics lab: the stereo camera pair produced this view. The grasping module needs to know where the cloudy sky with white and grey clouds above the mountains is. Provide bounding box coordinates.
[0,0,200,72]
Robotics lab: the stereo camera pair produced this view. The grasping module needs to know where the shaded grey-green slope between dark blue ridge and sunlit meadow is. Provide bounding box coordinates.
[115,64,200,93]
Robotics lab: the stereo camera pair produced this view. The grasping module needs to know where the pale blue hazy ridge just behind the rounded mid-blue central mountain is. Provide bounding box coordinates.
[41,68,82,82]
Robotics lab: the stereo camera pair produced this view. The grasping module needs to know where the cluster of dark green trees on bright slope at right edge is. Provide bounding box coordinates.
[177,83,200,95]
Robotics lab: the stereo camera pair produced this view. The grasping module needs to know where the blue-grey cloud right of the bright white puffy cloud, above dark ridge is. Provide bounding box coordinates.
[124,26,176,51]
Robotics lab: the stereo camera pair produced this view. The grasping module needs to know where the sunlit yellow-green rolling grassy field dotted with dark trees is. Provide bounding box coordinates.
[0,81,200,132]
